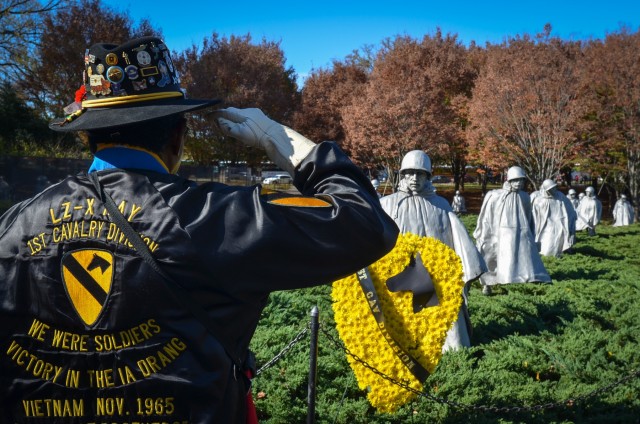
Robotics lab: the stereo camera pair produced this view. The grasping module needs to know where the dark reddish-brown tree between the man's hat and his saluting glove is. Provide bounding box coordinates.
[175,33,298,166]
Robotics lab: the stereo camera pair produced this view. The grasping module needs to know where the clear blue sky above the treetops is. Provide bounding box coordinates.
[104,0,640,84]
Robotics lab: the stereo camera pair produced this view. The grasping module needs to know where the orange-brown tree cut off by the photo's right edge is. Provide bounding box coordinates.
[584,28,640,213]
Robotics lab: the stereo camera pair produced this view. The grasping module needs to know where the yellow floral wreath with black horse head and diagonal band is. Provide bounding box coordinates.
[331,233,464,412]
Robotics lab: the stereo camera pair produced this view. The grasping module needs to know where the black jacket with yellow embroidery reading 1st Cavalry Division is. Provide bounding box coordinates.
[0,143,398,423]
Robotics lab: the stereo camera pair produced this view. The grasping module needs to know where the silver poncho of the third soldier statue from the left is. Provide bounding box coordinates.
[531,188,577,257]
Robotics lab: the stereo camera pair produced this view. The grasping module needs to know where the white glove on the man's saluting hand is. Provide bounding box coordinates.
[215,107,315,176]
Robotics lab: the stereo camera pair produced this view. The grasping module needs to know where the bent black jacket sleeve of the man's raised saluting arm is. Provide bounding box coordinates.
[184,142,398,292]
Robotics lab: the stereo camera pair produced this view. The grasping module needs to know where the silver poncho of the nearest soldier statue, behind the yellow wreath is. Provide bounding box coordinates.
[380,180,487,351]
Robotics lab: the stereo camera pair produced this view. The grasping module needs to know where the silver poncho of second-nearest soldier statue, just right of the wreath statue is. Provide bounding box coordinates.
[473,182,551,286]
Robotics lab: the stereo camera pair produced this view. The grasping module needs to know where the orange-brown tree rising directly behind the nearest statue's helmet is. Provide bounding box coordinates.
[342,30,474,191]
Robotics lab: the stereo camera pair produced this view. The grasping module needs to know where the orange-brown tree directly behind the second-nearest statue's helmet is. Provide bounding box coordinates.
[468,25,585,186]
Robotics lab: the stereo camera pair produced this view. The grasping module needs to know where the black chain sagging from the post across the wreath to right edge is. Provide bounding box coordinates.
[320,325,640,413]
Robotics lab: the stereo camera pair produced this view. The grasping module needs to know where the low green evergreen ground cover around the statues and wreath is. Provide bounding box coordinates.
[252,215,640,424]
